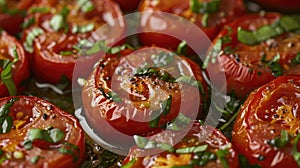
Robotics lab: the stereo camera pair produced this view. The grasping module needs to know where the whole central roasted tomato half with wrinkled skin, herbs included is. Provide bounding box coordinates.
[82,47,209,144]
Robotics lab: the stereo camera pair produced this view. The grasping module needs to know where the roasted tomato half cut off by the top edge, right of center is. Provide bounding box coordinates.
[139,0,244,49]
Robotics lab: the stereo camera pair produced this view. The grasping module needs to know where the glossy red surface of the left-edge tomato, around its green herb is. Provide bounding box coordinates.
[0,32,29,97]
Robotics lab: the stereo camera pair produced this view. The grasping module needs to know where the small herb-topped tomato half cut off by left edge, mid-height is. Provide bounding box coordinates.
[0,31,29,97]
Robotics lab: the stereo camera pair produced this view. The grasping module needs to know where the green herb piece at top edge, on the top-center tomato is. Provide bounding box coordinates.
[190,0,221,14]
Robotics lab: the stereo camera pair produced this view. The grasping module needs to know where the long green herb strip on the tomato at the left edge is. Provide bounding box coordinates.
[1,46,19,96]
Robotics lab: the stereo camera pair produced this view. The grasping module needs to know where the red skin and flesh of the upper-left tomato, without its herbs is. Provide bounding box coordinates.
[22,0,125,83]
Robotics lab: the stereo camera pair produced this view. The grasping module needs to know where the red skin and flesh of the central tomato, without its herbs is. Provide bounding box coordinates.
[82,47,209,143]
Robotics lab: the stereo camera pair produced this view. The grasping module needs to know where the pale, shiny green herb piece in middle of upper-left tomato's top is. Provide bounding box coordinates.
[50,7,70,31]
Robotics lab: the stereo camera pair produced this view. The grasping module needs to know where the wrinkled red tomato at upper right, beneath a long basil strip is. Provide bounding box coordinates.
[208,13,300,98]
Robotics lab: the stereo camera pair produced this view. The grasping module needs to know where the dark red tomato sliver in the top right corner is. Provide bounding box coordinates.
[253,0,300,13]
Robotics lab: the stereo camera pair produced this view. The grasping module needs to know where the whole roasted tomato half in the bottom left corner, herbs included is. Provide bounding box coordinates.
[0,96,85,168]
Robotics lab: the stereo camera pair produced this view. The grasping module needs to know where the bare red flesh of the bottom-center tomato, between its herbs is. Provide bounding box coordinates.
[122,122,239,168]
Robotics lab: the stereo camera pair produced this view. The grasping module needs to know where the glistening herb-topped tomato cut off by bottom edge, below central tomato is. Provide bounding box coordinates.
[123,123,239,168]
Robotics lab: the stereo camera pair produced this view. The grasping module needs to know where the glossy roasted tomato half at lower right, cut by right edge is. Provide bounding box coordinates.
[232,76,300,167]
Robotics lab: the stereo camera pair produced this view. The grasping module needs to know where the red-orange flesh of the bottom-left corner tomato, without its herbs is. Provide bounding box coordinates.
[0,96,85,168]
